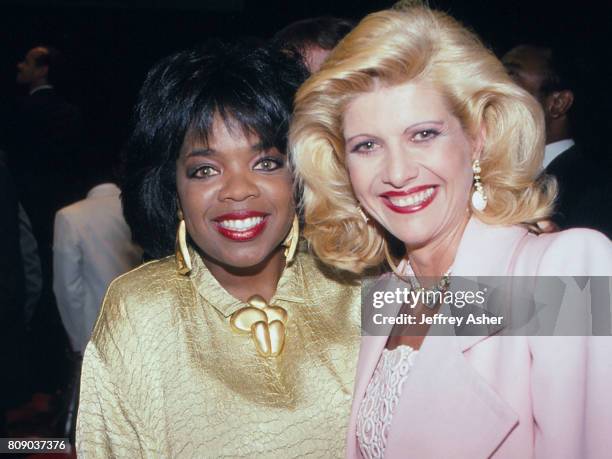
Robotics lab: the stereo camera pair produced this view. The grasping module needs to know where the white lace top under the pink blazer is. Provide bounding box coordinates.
[357,345,418,459]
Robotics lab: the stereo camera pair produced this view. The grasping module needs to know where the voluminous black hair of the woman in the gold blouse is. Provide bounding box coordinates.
[122,40,307,258]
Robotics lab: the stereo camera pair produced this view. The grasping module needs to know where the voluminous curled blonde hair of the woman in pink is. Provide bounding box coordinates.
[289,6,556,273]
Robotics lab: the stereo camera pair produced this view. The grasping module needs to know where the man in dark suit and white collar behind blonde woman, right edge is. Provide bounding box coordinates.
[502,45,612,237]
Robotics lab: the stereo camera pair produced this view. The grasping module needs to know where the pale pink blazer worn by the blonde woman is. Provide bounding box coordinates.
[347,218,612,459]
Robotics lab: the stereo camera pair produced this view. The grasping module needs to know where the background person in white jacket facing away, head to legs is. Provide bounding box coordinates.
[53,143,142,439]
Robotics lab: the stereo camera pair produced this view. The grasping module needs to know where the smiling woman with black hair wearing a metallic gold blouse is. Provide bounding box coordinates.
[77,42,359,457]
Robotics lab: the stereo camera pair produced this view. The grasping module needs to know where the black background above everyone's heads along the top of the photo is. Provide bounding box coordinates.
[0,0,612,155]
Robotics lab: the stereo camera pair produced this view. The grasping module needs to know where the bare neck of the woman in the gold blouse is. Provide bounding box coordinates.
[202,247,285,302]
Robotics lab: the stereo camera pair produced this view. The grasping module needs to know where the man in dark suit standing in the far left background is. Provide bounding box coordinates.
[9,46,81,258]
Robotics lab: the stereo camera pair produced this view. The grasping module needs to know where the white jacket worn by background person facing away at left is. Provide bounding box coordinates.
[53,183,142,355]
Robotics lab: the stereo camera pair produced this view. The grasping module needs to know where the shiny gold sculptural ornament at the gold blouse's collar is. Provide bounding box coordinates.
[230,295,289,357]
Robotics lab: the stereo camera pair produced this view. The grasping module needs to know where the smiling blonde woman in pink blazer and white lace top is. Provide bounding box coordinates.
[290,7,612,458]
